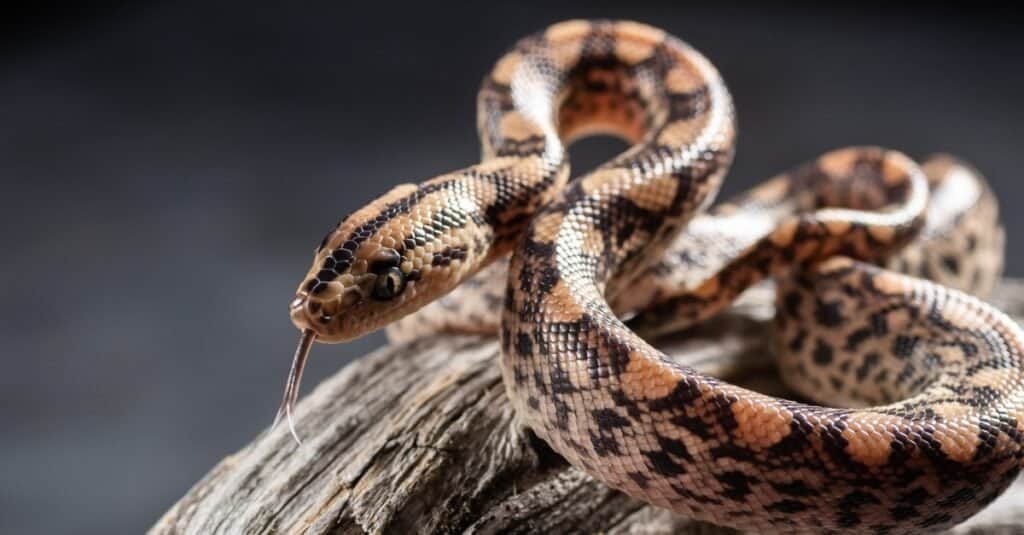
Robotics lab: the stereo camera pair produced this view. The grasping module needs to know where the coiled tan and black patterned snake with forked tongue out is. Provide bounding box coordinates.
[279,20,1024,533]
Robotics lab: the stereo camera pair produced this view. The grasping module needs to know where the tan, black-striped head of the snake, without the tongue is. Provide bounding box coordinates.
[290,184,475,343]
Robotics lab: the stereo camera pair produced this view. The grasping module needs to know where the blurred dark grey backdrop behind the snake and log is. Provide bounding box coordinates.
[0,0,1024,533]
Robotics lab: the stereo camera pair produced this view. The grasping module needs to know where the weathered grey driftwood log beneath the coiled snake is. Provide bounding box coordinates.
[151,281,1024,534]
